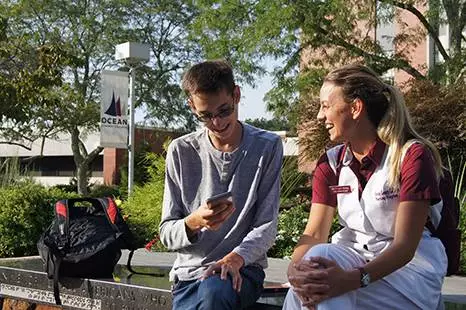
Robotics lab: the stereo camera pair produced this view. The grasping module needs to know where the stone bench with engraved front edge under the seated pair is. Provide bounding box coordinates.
[0,250,466,310]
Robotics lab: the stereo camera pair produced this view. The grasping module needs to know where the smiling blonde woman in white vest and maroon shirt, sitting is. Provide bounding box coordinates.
[283,65,447,310]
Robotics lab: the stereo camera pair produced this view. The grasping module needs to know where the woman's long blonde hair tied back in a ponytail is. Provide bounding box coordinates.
[324,64,442,189]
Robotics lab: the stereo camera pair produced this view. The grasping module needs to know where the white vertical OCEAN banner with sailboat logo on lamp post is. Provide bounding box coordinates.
[100,71,129,149]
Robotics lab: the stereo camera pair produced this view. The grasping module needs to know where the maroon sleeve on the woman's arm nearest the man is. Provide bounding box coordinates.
[312,154,337,207]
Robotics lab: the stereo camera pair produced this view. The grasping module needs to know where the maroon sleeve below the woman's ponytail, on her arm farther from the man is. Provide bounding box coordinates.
[400,143,440,204]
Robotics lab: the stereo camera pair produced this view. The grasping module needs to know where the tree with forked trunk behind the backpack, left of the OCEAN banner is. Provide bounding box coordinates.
[2,0,130,194]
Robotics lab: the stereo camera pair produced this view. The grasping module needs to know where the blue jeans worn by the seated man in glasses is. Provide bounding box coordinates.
[172,266,265,310]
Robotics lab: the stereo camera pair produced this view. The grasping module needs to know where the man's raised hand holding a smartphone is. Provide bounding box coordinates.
[185,199,235,235]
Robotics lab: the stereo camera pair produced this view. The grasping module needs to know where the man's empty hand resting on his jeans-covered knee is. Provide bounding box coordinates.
[201,252,244,293]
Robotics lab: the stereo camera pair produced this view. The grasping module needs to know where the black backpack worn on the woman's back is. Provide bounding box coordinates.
[426,168,461,276]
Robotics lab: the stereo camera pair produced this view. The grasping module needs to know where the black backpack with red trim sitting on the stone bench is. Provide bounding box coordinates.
[37,198,136,305]
